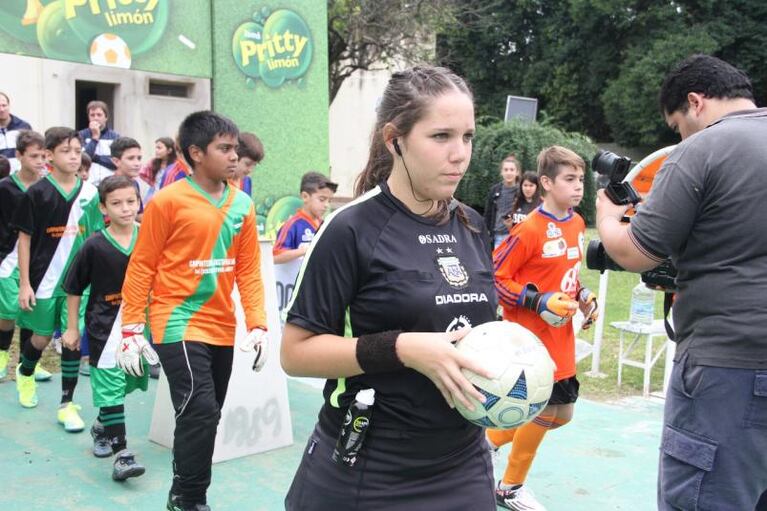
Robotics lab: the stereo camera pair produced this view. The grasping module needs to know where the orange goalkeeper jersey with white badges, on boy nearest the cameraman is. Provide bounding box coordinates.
[493,207,586,380]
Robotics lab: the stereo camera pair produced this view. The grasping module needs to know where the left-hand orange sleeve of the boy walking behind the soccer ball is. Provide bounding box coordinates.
[493,223,535,309]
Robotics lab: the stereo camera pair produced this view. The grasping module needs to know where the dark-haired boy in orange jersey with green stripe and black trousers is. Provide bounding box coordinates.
[116,111,266,511]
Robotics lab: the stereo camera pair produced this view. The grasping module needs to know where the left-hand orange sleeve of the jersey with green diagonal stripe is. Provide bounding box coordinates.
[122,198,170,324]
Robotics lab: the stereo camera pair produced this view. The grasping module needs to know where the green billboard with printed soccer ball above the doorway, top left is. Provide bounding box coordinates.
[0,0,211,78]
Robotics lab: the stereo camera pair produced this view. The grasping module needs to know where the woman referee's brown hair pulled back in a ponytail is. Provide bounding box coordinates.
[354,66,474,226]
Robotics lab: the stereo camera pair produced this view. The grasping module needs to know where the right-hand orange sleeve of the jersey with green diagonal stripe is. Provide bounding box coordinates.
[234,205,266,331]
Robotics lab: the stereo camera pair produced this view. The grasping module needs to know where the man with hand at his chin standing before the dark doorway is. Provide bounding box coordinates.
[80,101,120,186]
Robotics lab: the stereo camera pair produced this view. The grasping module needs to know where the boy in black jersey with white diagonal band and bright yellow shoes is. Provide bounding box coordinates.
[12,127,104,432]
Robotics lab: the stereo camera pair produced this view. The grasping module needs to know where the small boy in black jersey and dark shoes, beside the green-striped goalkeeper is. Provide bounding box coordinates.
[62,176,148,481]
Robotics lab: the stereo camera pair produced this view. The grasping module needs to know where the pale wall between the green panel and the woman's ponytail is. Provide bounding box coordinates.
[329,66,391,197]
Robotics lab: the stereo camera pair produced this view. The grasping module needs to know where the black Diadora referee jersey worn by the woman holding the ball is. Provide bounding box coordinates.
[287,183,497,452]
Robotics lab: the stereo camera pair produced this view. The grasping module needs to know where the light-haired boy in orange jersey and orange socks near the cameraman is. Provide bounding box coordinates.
[487,146,597,510]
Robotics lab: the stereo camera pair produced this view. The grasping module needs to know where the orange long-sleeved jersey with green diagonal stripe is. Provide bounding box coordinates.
[122,177,266,346]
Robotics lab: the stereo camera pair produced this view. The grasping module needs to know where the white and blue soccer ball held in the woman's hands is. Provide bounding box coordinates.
[455,321,555,429]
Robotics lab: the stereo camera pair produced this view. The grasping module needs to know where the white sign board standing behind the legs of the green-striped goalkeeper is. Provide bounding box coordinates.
[149,241,293,463]
